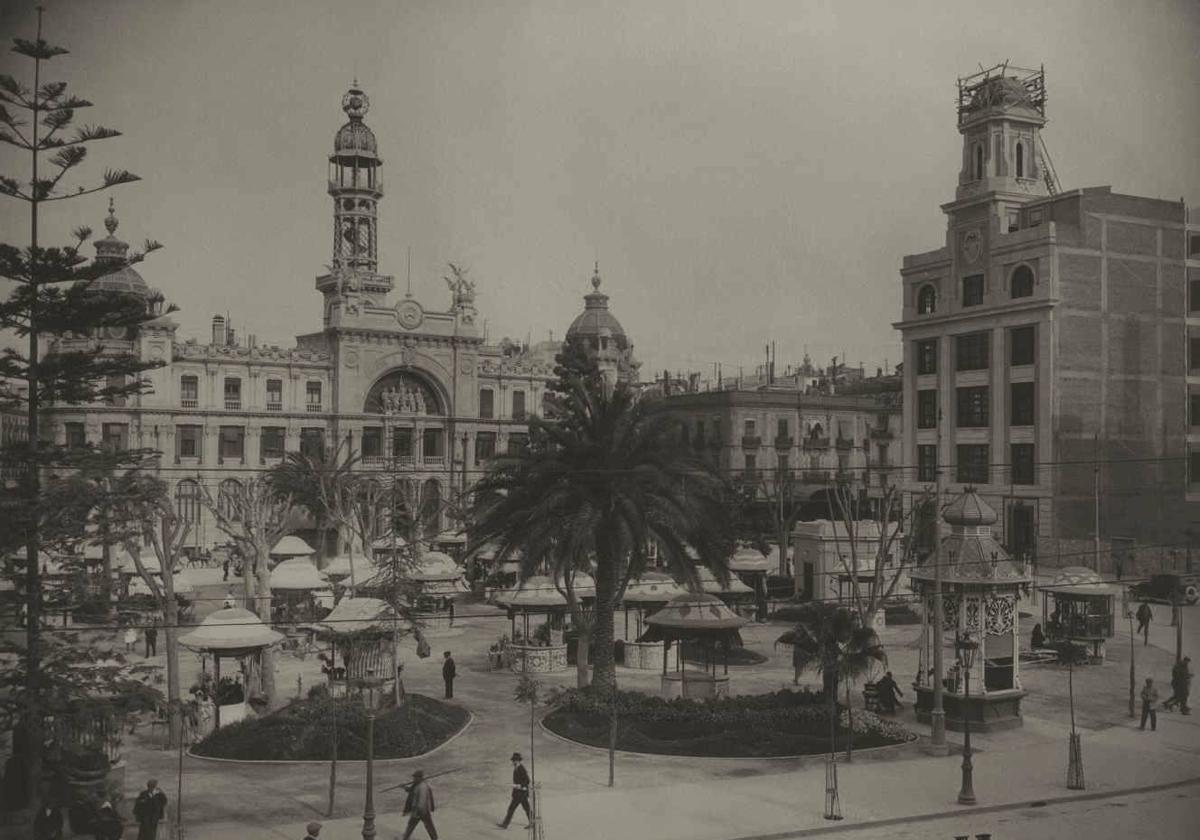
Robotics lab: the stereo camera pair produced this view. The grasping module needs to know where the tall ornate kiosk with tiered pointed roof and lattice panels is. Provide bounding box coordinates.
[911,487,1032,732]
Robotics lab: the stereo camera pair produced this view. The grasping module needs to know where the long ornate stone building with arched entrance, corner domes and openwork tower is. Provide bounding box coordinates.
[38,85,636,545]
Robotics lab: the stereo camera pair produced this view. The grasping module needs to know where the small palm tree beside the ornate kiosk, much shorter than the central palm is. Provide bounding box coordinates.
[775,601,888,760]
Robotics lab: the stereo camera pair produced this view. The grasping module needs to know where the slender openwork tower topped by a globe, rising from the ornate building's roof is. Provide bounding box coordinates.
[317,80,391,326]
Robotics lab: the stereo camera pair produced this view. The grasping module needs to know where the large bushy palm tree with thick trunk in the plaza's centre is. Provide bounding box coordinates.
[472,343,732,692]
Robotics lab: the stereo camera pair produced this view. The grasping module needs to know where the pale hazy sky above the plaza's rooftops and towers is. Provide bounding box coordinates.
[0,0,1200,378]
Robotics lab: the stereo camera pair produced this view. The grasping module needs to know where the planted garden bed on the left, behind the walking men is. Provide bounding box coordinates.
[192,692,470,761]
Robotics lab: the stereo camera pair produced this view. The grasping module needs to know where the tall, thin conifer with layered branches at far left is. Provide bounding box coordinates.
[0,12,160,816]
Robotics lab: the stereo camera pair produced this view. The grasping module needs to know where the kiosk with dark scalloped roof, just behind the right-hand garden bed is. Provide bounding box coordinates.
[642,593,746,700]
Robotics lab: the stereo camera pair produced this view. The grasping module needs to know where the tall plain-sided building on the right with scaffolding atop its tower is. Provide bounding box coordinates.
[895,65,1200,569]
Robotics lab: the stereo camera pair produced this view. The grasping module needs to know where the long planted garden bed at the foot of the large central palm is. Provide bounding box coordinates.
[544,689,913,757]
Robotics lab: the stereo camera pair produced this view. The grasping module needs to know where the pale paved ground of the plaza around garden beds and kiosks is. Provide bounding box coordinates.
[108,571,1200,840]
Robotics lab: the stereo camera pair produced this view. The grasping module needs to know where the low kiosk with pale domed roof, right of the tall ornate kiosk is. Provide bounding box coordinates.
[1040,566,1117,662]
